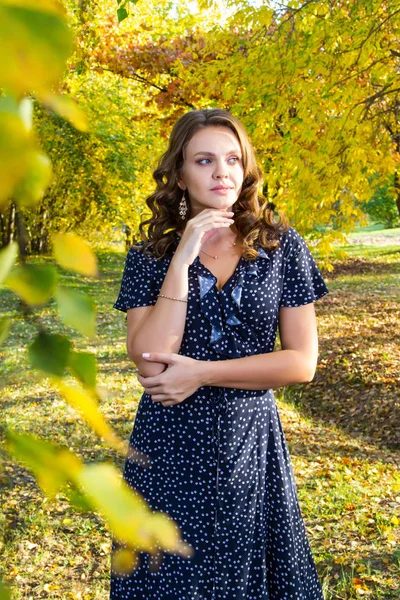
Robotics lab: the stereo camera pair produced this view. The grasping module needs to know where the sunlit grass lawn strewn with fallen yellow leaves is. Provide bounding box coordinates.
[0,241,400,600]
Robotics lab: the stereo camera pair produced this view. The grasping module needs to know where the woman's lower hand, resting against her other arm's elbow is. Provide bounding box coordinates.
[138,352,204,406]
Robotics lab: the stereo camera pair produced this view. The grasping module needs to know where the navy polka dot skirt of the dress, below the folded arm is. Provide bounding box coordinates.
[110,388,323,600]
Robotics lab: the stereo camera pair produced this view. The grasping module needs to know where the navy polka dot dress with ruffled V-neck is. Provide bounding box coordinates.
[110,228,328,600]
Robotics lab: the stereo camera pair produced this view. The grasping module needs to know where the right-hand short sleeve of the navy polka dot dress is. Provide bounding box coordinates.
[280,227,329,307]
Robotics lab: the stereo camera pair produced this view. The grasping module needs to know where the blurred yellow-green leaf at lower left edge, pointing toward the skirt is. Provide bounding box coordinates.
[6,430,83,497]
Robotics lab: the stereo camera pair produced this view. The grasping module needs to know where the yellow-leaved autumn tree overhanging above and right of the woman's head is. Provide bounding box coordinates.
[91,0,400,253]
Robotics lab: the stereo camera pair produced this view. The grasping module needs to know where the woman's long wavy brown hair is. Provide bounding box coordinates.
[140,108,288,259]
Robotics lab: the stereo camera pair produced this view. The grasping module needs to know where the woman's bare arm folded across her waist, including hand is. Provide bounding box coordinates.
[139,303,318,406]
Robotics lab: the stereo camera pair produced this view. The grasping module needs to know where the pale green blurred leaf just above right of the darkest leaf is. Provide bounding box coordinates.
[57,287,96,337]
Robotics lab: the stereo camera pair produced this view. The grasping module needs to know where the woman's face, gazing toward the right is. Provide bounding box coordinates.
[178,127,243,217]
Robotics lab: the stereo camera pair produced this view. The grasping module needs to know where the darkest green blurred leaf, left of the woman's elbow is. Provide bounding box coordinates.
[28,331,71,377]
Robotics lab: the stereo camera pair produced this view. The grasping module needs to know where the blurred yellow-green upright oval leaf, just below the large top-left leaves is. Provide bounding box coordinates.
[14,152,52,206]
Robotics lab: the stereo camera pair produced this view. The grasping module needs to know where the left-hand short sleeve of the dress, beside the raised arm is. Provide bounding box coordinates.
[114,248,159,312]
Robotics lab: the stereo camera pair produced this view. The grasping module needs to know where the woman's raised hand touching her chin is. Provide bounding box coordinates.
[172,208,235,265]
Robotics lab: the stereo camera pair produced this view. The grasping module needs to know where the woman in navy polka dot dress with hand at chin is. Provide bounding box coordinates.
[111,109,328,600]
